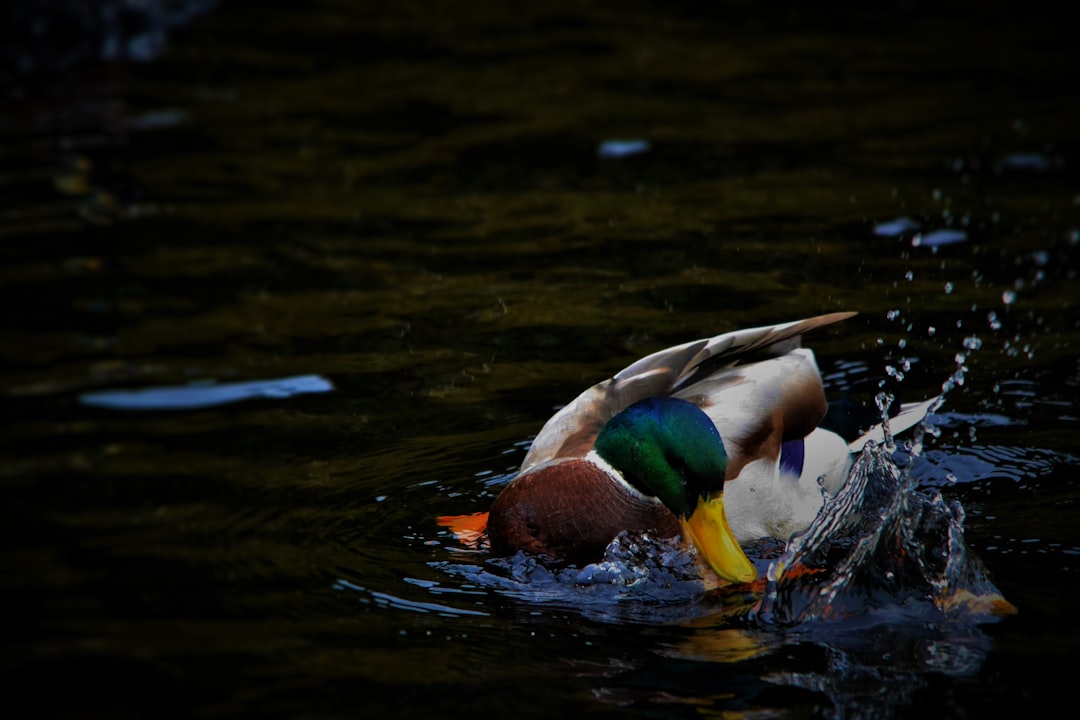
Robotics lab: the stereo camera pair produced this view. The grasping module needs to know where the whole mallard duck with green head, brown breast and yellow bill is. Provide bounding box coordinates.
[444,312,933,583]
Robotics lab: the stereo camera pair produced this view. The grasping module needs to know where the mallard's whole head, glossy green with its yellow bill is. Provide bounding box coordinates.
[594,397,757,583]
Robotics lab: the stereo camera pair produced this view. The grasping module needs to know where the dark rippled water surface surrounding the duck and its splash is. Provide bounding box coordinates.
[0,0,1080,718]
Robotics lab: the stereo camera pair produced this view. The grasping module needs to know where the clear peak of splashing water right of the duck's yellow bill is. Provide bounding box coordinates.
[752,434,1015,626]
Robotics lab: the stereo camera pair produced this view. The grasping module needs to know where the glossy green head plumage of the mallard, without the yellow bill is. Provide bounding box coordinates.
[595,397,728,517]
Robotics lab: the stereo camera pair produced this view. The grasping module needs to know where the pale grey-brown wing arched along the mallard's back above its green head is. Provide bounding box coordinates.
[522,312,855,472]
